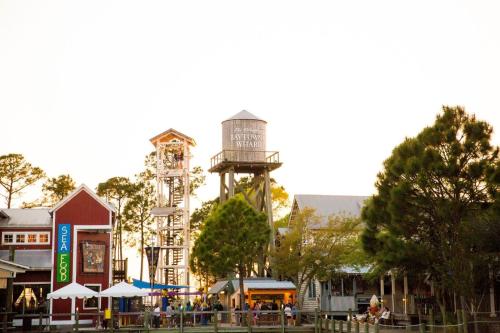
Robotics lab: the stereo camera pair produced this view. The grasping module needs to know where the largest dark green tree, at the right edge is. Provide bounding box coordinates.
[362,107,500,308]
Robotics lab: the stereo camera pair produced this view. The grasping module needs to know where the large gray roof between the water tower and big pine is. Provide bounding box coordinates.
[290,194,369,224]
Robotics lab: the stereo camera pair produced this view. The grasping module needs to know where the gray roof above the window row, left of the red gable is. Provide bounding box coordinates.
[0,208,52,228]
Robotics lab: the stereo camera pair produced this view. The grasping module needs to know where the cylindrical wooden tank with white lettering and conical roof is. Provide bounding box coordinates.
[222,110,267,162]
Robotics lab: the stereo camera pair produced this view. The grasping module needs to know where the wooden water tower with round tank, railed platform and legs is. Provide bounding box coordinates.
[209,110,282,246]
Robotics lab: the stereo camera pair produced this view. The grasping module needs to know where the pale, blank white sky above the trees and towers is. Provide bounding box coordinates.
[0,0,500,206]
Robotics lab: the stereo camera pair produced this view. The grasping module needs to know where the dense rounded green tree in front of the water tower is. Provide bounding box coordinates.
[190,195,270,309]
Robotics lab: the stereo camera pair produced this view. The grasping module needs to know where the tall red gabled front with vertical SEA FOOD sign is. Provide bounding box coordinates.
[50,185,114,324]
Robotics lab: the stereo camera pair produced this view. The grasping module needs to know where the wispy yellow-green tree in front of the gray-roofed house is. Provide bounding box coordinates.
[271,208,365,308]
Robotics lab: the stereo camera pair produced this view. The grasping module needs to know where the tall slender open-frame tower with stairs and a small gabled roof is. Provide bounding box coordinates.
[150,129,196,285]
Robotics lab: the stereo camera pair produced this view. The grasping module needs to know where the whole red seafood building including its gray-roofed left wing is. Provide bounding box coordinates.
[0,185,115,324]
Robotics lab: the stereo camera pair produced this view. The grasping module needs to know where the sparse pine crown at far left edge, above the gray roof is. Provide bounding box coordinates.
[0,154,45,208]
